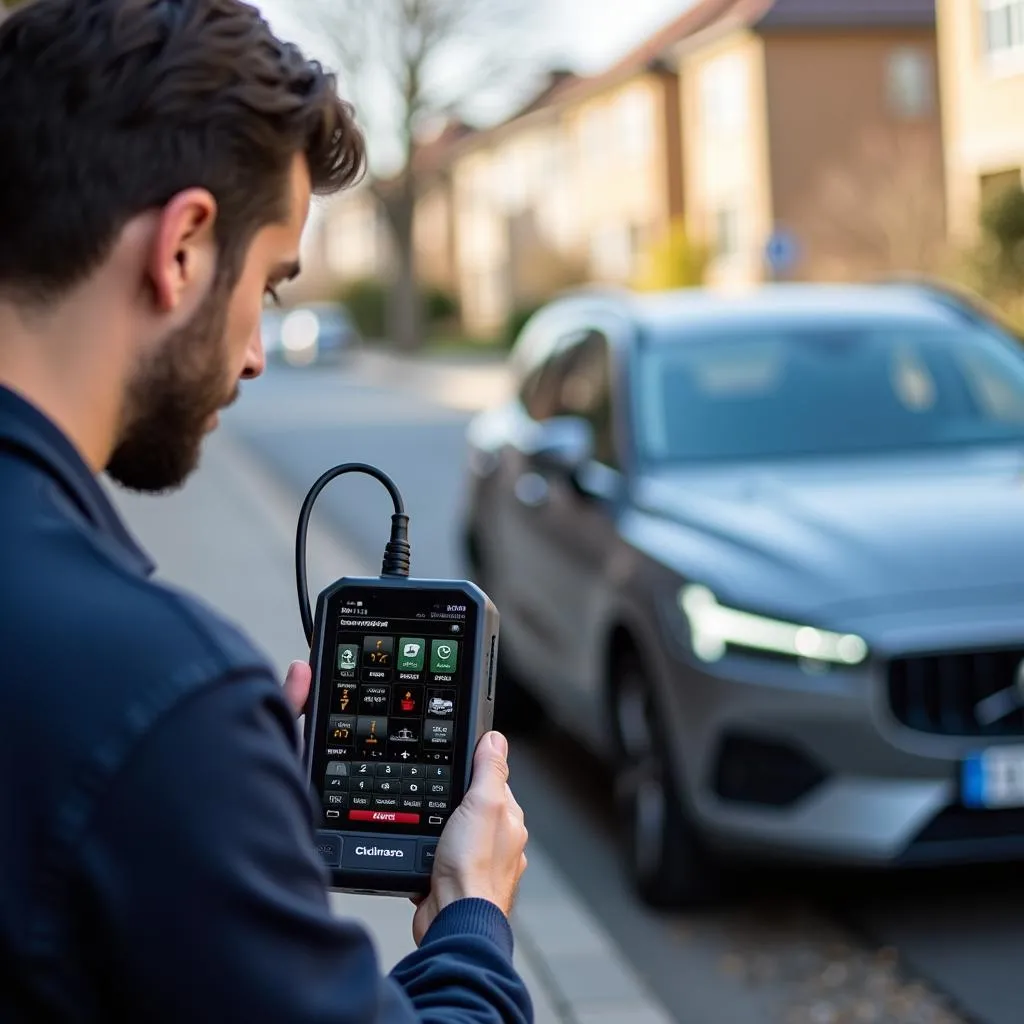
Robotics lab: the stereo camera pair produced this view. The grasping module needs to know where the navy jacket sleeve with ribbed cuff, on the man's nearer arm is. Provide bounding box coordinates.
[76,678,532,1024]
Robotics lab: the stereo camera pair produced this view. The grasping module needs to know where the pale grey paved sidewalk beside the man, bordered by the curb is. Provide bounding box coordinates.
[108,430,671,1024]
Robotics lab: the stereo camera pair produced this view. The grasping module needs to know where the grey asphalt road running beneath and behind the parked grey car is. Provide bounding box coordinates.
[225,354,1024,1024]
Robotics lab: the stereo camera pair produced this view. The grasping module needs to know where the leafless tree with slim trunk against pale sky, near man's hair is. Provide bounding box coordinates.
[317,0,539,348]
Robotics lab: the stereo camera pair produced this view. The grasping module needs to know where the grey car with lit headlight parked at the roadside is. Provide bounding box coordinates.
[463,285,1024,905]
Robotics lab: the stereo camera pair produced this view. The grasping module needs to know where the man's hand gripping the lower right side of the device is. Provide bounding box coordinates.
[413,732,527,945]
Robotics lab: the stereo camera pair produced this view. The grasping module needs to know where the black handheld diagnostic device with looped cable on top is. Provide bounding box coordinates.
[295,463,499,896]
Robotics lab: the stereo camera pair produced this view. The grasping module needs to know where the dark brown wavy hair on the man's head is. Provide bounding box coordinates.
[0,0,365,302]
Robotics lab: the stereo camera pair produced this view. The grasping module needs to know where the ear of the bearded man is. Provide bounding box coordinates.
[146,188,217,313]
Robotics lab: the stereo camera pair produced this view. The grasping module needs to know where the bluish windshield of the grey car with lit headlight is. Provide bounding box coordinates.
[636,326,1024,463]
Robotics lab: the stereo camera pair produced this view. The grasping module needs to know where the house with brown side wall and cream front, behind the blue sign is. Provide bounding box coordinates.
[672,0,942,286]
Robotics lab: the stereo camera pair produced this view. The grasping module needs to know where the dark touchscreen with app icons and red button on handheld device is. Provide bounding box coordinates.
[312,587,477,836]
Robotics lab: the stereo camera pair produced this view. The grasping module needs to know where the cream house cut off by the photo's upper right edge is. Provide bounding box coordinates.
[938,0,1024,245]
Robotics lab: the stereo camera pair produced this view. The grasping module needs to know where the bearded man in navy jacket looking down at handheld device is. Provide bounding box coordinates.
[0,0,531,1024]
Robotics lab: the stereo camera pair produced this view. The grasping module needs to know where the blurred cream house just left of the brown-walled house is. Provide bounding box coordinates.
[453,44,682,334]
